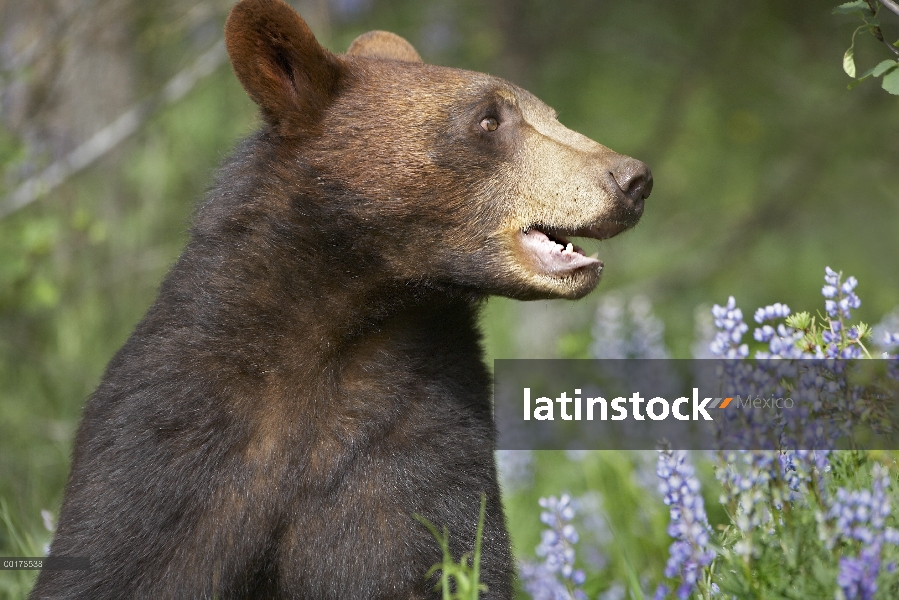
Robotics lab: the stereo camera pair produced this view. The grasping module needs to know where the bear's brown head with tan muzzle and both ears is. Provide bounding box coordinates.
[225,0,652,299]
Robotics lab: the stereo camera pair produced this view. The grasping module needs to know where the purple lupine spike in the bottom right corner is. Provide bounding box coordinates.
[827,463,899,600]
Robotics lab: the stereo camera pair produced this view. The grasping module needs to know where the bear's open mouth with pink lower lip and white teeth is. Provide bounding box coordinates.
[521,221,629,277]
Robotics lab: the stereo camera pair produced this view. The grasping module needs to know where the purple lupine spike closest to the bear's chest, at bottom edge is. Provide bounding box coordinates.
[520,494,587,600]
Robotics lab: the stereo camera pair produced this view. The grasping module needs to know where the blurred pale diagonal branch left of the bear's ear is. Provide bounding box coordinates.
[0,40,227,219]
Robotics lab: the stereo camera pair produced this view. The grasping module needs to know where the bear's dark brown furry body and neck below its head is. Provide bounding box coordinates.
[33,115,512,598]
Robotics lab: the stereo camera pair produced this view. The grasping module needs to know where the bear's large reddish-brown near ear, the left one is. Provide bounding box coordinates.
[225,0,341,133]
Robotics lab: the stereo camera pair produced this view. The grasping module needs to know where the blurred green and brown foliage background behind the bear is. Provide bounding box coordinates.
[0,0,899,597]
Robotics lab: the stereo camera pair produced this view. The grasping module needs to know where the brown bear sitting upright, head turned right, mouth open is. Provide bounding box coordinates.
[32,0,652,600]
